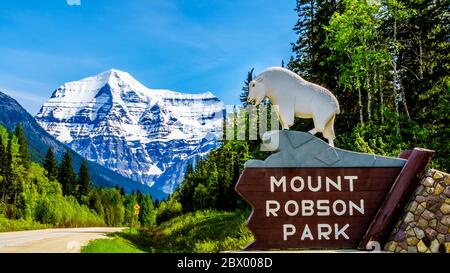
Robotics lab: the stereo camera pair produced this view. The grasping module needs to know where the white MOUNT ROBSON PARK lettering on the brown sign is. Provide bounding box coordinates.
[265,175,365,241]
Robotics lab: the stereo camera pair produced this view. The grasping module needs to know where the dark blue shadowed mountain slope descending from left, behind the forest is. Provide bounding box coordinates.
[0,92,165,199]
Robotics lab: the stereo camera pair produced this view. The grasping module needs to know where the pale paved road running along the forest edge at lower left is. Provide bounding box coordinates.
[0,227,123,253]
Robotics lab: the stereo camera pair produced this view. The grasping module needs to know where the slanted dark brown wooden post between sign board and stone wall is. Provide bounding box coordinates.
[358,148,434,250]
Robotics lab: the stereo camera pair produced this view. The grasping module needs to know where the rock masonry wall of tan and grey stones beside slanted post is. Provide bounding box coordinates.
[384,170,450,253]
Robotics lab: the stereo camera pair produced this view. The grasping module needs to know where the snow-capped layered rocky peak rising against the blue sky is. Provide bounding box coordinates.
[36,69,224,193]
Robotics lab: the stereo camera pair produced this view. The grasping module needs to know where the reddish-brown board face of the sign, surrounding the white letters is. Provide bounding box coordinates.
[235,164,401,249]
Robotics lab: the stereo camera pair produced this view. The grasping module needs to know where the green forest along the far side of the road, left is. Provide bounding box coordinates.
[0,124,167,232]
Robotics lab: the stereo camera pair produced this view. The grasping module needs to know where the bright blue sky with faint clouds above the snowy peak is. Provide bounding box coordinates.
[0,0,296,114]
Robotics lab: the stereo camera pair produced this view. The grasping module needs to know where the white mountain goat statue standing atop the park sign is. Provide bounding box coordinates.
[247,67,340,146]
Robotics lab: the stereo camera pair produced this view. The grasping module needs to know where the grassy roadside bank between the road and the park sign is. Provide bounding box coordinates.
[81,208,253,253]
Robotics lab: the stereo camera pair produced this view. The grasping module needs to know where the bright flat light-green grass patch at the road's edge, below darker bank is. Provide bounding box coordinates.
[81,234,144,253]
